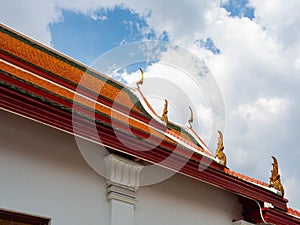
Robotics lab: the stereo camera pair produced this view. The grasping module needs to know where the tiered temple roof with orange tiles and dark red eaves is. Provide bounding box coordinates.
[0,24,299,224]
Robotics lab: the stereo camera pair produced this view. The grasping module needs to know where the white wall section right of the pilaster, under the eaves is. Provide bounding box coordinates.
[135,171,241,225]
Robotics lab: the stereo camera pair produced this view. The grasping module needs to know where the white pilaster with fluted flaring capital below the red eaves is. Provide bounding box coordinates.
[105,154,143,225]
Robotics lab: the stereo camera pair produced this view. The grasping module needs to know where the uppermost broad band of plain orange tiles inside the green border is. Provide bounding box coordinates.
[0,27,139,111]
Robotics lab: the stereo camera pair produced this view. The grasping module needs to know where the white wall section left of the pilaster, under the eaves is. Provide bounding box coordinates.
[0,110,109,225]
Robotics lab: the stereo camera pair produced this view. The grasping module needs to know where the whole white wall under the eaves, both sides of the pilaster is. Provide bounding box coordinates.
[0,110,241,225]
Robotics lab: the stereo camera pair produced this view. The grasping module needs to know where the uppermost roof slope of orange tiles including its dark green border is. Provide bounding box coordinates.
[1,24,148,117]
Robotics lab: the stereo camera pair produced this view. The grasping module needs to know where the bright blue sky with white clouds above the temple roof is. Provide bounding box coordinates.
[0,0,300,210]
